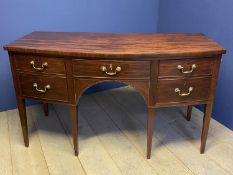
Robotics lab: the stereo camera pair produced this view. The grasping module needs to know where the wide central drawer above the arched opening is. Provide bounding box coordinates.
[73,60,150,79]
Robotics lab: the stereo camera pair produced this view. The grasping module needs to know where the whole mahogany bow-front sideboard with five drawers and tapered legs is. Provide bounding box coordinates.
[4,32,226,158]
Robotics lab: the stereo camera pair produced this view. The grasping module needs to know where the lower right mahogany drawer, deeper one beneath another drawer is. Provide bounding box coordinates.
[157,77,211,103]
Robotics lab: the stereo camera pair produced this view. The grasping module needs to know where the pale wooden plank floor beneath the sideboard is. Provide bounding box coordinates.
[0,87,233,175]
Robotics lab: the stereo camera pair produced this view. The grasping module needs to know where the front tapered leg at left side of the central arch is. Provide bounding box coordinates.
[69,105,78,156]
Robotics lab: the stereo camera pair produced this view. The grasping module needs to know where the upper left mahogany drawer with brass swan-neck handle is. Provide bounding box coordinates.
[15,55,66,74]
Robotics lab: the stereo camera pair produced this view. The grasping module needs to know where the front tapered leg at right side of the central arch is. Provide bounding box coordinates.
[147,107,155,159]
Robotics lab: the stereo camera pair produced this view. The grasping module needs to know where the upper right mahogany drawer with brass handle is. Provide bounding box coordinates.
[159,58,214,78]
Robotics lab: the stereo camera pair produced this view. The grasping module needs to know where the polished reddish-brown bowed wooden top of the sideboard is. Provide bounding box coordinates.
[4,32,226,58]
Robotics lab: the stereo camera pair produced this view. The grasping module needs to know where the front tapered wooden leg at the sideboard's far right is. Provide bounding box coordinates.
[200,104,213,154]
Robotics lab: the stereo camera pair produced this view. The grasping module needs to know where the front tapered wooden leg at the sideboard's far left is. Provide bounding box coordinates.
[17,98,29,147]
